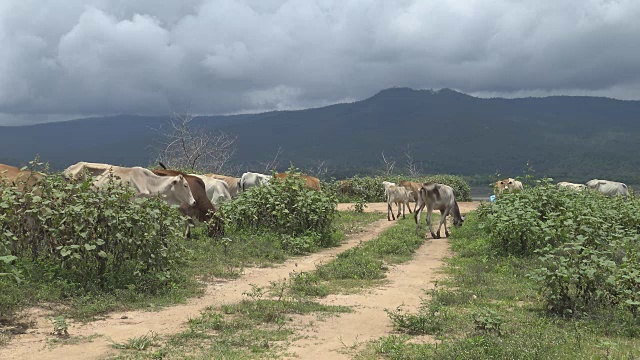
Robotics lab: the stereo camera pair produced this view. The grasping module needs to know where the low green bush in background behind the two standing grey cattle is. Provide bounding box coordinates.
[323,174,471,202]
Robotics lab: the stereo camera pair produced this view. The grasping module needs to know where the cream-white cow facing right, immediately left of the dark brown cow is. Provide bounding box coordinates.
[93,166,196,206]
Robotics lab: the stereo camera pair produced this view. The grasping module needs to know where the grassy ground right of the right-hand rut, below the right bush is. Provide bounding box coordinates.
[358,214,640,359]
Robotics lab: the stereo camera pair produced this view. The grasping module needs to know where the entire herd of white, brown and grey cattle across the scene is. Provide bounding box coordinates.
[0,162,629,239]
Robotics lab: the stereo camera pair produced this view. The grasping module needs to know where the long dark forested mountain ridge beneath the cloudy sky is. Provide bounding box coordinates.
[0,88,640,183]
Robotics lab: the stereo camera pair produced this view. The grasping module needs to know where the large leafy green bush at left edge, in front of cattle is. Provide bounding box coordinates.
[0,174,185,294]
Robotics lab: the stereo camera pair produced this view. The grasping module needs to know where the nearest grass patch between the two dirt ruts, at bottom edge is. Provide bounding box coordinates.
[109,284,351,359]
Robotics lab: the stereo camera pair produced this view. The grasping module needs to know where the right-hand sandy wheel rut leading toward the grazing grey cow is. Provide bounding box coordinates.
[288,239,450,359]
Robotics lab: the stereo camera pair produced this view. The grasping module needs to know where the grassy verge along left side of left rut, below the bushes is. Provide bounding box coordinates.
[0,212,382,326]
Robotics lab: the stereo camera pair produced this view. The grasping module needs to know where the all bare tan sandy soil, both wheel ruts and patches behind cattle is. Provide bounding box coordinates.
[0,203,477,360]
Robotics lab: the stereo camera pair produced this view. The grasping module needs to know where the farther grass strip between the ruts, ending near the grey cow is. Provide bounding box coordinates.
[293,217,432,296]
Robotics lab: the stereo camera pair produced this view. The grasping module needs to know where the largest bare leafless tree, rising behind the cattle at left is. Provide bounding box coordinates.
[154,113,236,173]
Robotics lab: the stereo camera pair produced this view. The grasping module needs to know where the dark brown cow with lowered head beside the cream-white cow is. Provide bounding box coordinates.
[152,164,224,236]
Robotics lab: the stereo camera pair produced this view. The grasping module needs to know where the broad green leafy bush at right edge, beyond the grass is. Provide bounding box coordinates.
[478,180,640,316]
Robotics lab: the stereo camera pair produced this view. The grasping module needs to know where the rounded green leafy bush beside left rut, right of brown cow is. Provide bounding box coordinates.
[220,169,338,248]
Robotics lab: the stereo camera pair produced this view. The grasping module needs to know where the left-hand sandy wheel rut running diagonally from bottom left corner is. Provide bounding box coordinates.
[0,219,395,360]
